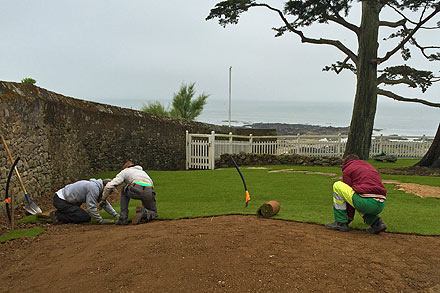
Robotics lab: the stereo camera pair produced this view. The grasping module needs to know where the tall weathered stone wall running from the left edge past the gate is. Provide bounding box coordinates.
[0,81,276,213]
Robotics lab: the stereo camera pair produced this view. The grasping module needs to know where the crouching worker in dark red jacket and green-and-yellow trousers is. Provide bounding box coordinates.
[325,155,387,234]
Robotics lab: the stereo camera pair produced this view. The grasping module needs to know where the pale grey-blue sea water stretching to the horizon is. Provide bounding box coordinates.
[101,97,440,136]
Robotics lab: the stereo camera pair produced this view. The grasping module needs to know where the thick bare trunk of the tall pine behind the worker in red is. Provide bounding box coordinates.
[345,0,382,159]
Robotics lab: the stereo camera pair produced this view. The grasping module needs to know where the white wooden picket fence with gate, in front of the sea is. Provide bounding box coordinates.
[186,131,434,170]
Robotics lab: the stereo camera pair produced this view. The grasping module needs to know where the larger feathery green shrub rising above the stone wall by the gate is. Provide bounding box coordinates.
[170,82,209,120]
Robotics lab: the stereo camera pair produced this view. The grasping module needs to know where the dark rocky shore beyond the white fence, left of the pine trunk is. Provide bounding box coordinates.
[244,123,349,135]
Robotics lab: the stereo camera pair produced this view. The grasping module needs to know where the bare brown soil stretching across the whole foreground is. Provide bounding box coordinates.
[0,215,440,292]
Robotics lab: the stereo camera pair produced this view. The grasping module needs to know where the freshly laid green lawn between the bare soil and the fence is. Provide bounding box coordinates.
[95,160,440,235]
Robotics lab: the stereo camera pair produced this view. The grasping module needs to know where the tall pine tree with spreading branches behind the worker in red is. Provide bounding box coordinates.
[207,0,440,159]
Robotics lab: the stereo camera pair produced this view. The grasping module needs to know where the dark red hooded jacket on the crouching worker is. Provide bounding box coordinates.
[342,160,387,220]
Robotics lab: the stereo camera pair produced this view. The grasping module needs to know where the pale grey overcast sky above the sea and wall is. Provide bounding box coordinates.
[0,0,440,112]
